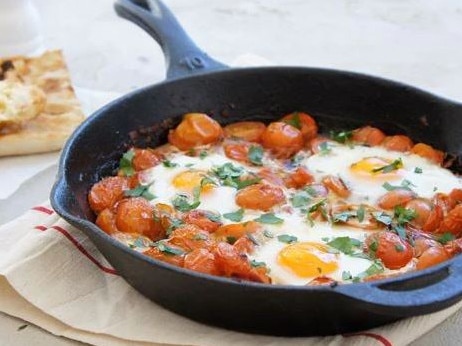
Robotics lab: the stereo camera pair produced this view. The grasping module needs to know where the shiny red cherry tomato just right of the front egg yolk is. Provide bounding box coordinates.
[366,231,413,269]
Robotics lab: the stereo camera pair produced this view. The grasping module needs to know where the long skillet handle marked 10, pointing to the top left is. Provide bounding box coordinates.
[114,0,228,79]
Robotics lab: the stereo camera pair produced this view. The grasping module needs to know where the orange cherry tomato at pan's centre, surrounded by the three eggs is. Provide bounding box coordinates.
[236,184,285,210]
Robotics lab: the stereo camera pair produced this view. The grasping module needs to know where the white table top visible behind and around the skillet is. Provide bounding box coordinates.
[0,0,462,345]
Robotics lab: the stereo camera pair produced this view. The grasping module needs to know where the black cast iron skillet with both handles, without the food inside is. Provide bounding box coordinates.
[51,0,462,336]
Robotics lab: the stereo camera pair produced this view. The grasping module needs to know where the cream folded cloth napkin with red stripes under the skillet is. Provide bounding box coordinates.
[0,203,462,346]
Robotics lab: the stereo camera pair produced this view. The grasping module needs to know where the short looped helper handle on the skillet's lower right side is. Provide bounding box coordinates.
[336,257,462,316]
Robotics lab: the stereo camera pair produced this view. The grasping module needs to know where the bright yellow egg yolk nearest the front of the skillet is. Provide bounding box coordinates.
[278,242,338,278]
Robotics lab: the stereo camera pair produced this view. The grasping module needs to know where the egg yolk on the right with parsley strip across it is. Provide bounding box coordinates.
[350,156,403,178]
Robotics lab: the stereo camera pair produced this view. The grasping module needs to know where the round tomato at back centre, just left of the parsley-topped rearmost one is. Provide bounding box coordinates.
[261,122,303,159]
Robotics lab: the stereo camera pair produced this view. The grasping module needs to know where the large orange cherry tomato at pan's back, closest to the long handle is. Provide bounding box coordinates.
[168,113,223,150]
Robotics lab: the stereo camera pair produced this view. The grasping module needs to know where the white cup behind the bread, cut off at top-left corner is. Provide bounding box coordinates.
[0,0,44,57]
